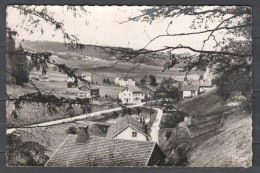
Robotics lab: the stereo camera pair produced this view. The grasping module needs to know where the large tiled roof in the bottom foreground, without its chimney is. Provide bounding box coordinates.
[45,134,158,167]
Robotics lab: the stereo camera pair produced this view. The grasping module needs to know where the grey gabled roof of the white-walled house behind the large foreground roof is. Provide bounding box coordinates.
[107,115,149,138]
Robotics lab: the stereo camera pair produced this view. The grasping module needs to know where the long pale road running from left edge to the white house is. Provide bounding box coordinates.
[6,103,144,134]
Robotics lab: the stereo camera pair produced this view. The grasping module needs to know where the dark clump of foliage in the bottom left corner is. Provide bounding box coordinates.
[6,134,49,166]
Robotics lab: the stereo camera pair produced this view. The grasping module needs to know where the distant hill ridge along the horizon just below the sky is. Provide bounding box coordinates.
[22,40,189,68]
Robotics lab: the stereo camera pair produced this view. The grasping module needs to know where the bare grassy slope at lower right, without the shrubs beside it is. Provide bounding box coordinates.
[179,91,252,167]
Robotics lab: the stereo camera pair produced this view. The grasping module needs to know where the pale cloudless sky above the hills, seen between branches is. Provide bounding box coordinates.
[7,6,237,53]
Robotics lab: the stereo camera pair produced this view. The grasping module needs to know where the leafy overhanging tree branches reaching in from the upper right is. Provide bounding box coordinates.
[103,6,252,105]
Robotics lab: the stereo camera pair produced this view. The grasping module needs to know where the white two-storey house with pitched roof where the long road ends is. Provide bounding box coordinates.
[119,86,142,104]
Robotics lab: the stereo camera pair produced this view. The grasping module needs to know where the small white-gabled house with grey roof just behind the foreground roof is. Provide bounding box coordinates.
[107,115,151,141]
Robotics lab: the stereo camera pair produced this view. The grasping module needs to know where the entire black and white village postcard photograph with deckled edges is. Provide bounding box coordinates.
[5,5,253,167]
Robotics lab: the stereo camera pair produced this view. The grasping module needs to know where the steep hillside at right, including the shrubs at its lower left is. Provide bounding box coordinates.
[160,90,252,167]
